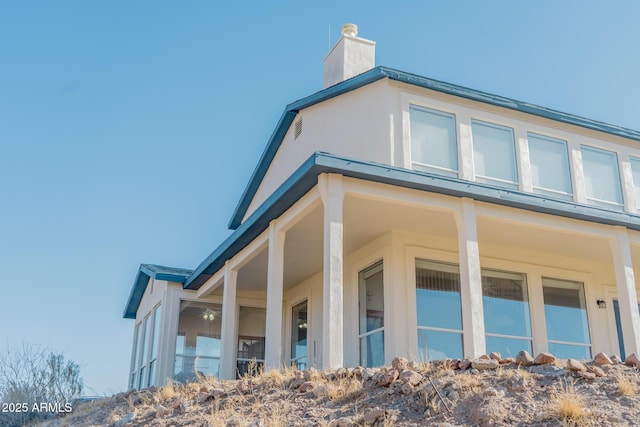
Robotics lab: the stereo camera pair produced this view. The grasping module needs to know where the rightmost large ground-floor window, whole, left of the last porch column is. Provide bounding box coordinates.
[542,277,591,359]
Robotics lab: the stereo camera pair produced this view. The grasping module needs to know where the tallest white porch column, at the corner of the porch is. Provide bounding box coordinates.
[318,174,344,369]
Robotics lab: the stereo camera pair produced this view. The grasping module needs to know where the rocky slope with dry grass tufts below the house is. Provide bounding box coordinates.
[36,352,640,427]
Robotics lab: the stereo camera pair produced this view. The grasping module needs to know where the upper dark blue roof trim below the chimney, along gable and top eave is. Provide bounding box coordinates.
[229,67,640,229]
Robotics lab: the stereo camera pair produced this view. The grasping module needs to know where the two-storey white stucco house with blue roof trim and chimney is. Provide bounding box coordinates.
[124,24,640,388]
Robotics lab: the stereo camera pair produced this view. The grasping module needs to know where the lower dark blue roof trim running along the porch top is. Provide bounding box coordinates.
[185,153,640,289]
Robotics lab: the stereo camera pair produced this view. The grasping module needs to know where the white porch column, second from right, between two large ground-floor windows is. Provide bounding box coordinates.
[456,197,486,357]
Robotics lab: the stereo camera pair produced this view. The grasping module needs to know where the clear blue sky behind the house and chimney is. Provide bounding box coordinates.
[0,0,640,394]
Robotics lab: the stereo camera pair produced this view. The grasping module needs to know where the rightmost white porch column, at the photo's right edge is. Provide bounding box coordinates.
[611,226,640,355]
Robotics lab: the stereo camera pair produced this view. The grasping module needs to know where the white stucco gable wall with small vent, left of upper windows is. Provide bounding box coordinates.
[243,79,398,221]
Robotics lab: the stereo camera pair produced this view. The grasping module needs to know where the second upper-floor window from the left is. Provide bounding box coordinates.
[471,120,518,188]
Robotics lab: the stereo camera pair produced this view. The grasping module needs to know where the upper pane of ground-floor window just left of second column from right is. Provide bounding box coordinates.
[416,260,462,330]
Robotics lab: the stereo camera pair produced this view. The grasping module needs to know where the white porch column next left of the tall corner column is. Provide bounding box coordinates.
[264,221,285,369]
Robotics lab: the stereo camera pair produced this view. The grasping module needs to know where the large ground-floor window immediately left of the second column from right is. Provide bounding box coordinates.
[416,259,462,360]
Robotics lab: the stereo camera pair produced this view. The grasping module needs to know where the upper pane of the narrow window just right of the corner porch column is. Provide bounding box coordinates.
[358,262,384,334]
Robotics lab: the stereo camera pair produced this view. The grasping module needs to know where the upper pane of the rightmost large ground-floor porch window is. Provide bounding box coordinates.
[542,277,591,344]
